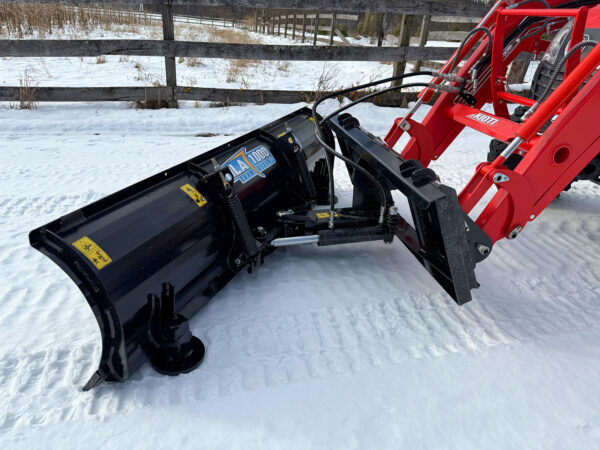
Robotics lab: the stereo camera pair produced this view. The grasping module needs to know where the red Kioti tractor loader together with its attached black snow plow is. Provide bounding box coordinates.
[30,0,600,390]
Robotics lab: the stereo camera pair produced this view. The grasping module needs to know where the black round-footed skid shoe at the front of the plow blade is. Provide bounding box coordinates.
[150,283,206,375]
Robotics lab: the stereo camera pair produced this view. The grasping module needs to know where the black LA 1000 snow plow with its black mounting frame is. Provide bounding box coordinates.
[30,109,491,389]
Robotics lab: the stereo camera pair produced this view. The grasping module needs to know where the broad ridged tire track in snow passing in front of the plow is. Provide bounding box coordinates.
[0,264,600,433]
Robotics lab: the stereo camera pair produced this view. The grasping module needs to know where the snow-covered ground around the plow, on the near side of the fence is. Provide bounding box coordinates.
[0,99,600,449]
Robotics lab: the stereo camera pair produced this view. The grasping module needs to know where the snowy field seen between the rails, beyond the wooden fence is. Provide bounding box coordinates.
[0,23,457,90]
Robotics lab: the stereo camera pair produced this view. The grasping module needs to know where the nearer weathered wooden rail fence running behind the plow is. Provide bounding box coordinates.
[0,0,500,107]
